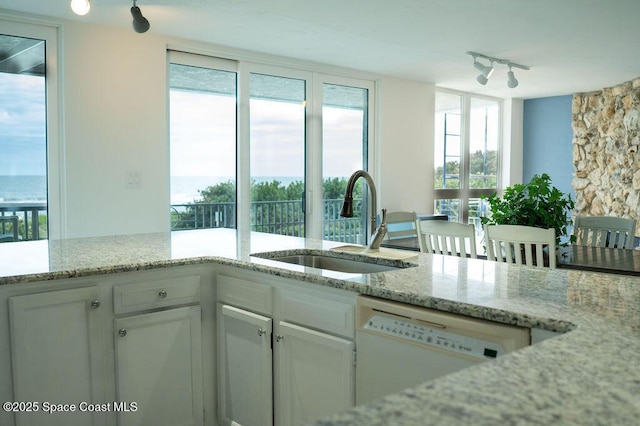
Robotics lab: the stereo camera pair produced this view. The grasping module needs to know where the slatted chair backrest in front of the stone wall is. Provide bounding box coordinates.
[573,216,636,249]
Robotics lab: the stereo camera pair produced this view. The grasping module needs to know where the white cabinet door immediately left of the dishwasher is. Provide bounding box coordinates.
[274,321,355,426]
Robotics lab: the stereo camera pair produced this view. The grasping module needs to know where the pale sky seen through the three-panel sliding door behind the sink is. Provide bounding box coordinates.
[170,91,362,177]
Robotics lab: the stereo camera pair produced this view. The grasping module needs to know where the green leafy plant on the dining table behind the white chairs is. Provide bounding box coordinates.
[481,173,575,244]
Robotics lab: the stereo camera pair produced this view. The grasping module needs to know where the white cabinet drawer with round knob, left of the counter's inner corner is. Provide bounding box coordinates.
[113,275,201,314]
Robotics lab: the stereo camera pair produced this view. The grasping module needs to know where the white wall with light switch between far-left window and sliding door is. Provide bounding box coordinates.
[61,22,169,238]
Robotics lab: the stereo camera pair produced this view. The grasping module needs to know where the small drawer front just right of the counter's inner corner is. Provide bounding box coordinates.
[217,274,273,315]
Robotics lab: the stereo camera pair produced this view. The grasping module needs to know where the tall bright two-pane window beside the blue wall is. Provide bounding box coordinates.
[434,92,501,249]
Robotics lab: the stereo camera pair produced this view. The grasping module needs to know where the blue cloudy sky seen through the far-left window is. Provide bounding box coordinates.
[0,73,47,176]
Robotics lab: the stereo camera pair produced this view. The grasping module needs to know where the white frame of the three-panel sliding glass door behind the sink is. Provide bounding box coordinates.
[167,50,377,239]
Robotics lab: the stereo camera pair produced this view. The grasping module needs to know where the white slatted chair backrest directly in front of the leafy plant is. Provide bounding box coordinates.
[484,225,556,268]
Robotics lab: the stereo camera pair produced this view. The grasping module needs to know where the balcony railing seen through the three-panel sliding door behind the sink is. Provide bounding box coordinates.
[171,199,366,244]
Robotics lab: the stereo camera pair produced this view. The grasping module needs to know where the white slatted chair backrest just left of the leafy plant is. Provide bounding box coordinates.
[417,220,478,257]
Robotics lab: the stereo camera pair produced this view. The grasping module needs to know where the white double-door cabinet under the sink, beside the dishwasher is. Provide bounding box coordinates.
[217,273,355,426]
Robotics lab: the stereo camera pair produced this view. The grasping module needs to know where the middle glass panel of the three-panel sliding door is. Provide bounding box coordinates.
[249,73,307,237]
